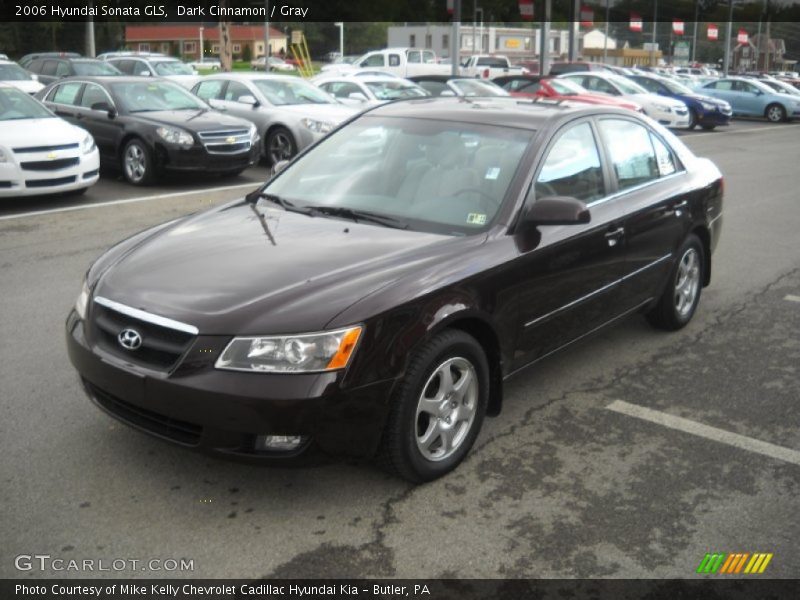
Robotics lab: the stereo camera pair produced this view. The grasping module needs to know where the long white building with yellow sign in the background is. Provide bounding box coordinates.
[387,23,617,60]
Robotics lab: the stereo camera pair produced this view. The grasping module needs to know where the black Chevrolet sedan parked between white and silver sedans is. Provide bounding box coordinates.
[37,77,259,185]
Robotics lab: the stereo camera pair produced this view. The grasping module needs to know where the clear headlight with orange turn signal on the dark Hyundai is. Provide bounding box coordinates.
[214,326,361,373]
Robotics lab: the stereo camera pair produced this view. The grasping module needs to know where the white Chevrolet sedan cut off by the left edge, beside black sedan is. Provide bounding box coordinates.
[0,83,100,198]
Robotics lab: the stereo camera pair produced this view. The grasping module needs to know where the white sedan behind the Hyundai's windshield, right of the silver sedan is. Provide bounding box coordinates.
[312,75,429,106]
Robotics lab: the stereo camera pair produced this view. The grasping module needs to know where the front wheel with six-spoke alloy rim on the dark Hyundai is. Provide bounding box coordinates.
[378,330,489,483]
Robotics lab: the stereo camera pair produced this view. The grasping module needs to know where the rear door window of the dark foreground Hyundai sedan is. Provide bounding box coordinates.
[599,119,660,191]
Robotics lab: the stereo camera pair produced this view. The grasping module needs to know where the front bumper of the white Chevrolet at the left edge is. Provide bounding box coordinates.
[0,148,100,198]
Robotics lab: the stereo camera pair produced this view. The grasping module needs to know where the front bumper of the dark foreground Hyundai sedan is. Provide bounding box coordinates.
[67,310,395,460]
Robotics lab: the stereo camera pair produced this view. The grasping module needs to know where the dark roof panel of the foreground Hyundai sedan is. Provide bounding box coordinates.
[366,97,634,131]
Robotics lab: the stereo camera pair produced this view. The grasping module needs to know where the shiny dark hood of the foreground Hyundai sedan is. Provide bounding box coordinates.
[94,202,472,335]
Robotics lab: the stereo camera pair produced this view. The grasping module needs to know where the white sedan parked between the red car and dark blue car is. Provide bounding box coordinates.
[559,71,690,128]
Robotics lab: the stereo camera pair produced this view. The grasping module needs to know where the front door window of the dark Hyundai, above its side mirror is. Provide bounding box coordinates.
[534,123,605,202]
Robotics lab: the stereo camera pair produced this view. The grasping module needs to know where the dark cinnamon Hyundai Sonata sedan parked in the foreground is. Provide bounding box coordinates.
[67,99,723,482]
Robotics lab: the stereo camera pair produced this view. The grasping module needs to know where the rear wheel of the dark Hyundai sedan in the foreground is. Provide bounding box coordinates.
[647,233,706,331]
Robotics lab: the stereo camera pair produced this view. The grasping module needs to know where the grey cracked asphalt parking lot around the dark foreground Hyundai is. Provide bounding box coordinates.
[0,121,800,578]
